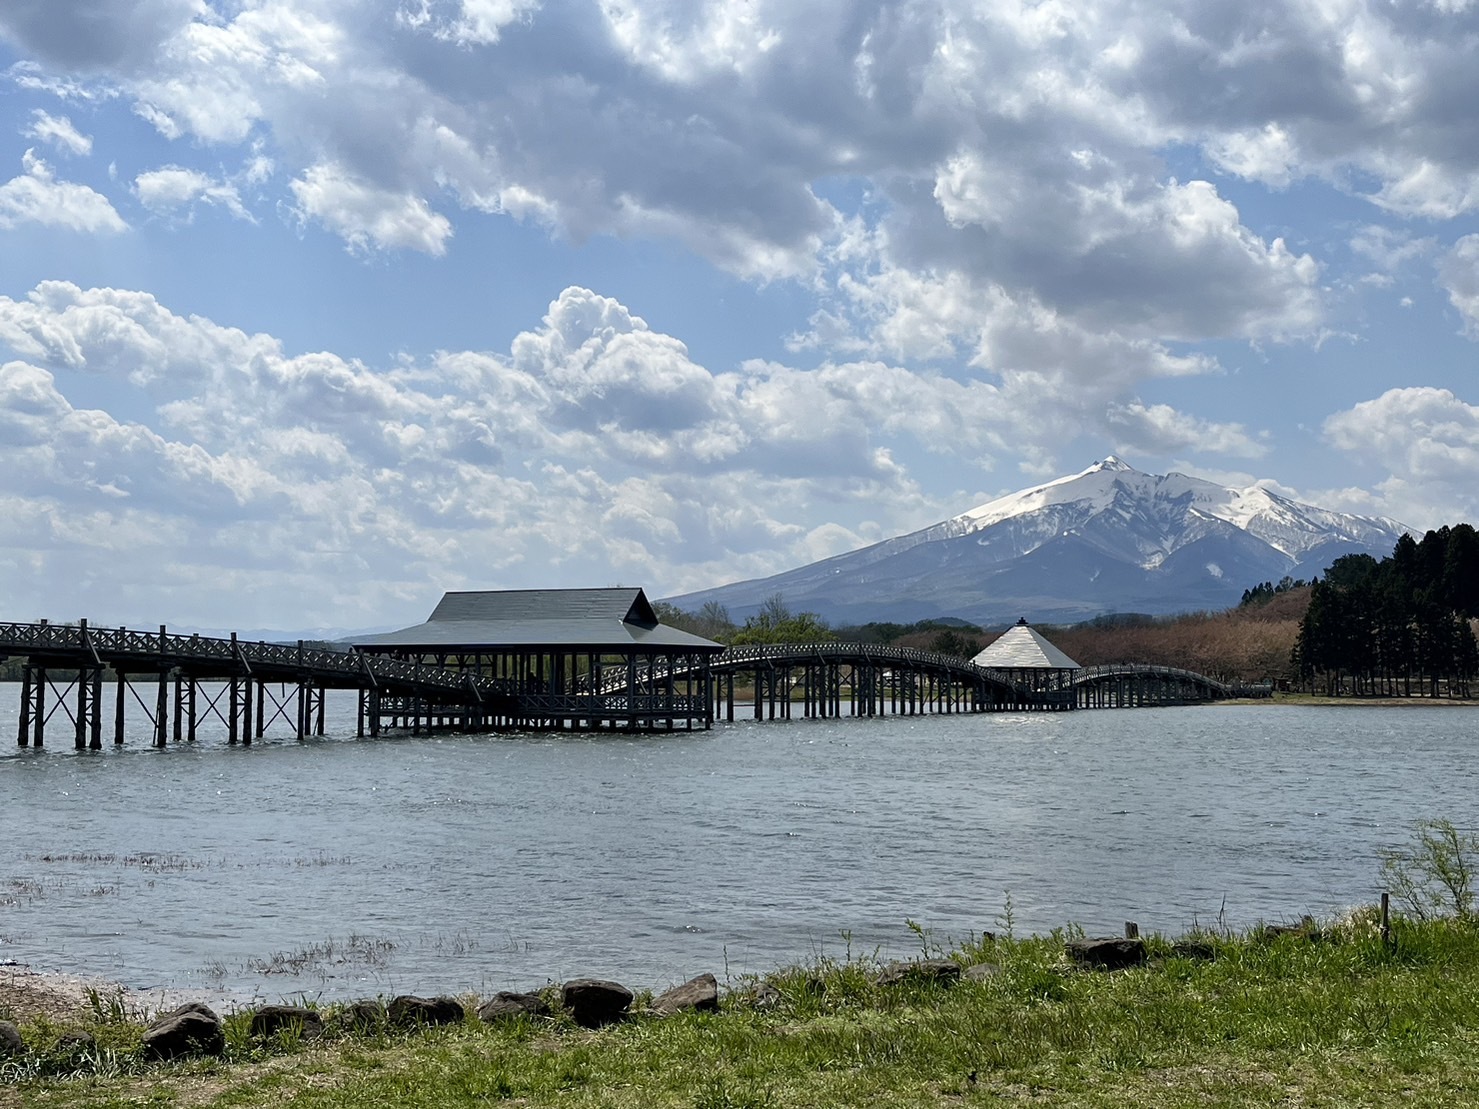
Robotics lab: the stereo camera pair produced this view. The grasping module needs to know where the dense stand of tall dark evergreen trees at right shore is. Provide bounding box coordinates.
[1294,523,1479,696]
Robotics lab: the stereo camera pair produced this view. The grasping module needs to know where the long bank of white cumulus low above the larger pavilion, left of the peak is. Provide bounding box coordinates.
[0,281,1195,623]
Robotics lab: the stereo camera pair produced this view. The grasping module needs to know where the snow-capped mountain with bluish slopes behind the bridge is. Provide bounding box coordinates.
[671,455,1409,624]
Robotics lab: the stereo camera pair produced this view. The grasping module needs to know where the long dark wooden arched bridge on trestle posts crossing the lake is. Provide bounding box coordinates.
[0,621,1270,750]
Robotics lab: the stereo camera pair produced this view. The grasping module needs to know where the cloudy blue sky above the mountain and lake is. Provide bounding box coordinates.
[0,0,1479,630]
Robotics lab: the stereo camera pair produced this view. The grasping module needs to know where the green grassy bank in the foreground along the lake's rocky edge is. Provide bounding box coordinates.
[0,914,1479,1109]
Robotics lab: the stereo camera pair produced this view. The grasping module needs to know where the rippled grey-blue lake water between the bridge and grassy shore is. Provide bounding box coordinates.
[0,685,1479,1001]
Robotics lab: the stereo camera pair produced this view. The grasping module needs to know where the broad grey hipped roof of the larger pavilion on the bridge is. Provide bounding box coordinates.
[353,589,723,654]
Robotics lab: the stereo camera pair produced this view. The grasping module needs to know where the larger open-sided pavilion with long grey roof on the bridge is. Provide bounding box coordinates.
[353,589,725,732]
